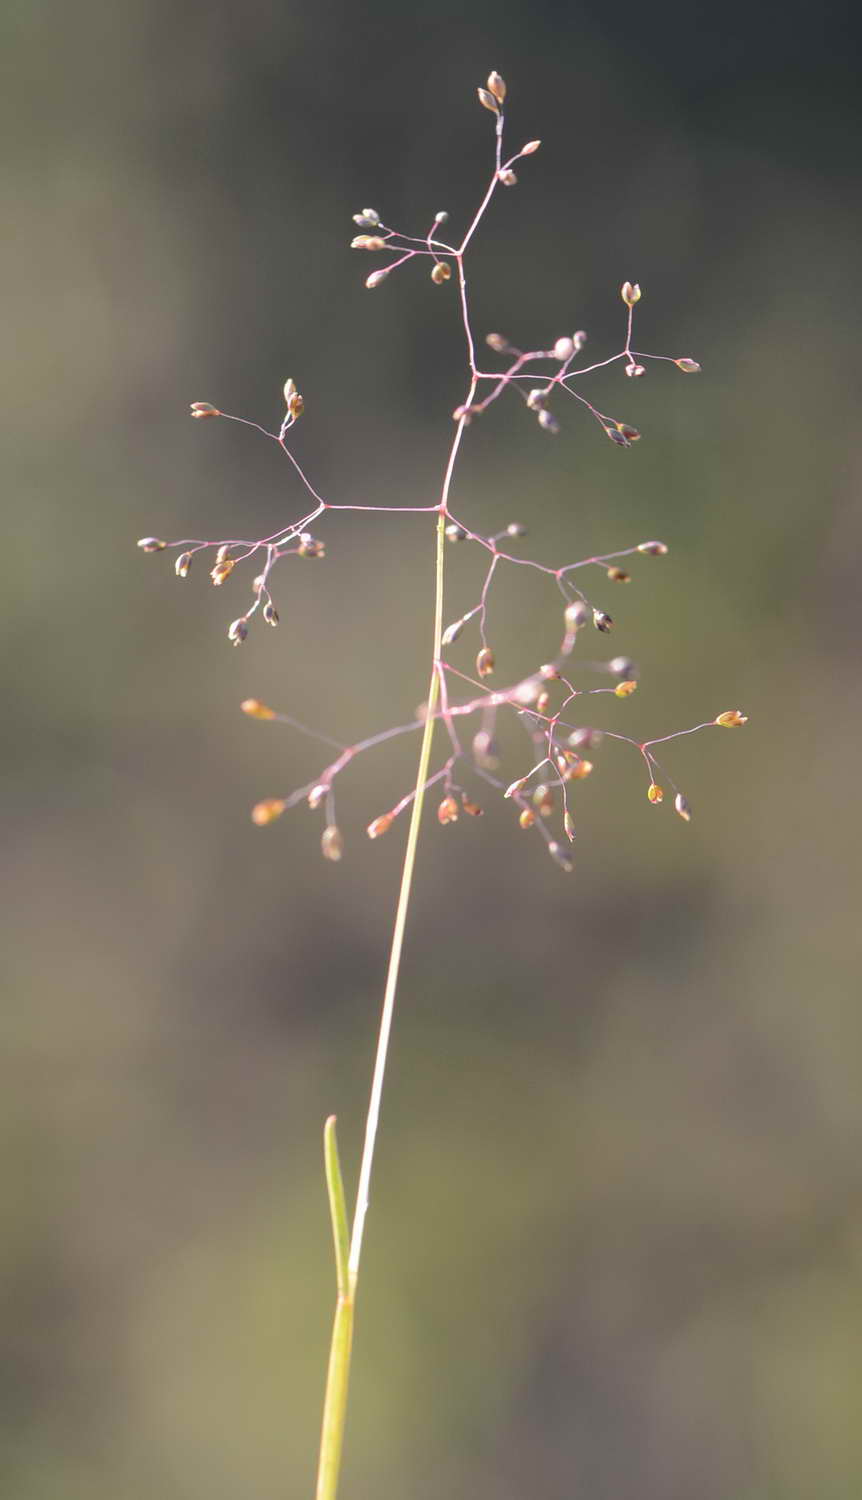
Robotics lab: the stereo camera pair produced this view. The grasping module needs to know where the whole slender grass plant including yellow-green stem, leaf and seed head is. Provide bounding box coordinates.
[138,72,745,1500]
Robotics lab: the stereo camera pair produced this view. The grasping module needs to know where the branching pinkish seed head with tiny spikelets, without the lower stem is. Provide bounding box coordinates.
[138,74,745,870]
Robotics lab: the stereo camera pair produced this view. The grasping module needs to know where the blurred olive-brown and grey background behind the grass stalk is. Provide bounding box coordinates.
[0,0,862,1500]
